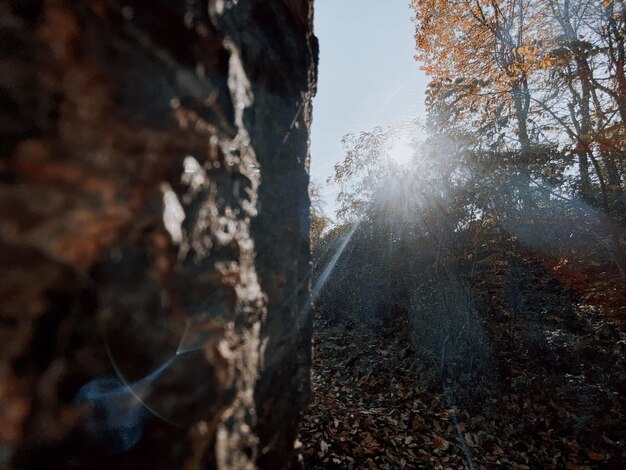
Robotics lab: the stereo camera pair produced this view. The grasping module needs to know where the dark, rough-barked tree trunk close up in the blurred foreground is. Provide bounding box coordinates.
[0,0,317,469]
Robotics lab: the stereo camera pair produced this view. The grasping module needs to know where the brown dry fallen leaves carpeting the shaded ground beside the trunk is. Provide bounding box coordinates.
[300,310,626,470]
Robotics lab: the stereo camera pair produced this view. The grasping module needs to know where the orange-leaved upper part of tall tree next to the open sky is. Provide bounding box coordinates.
[412,0,545,175]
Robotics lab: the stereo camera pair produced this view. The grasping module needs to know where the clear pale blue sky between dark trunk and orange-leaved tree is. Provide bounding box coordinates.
[311,0,427,216]
